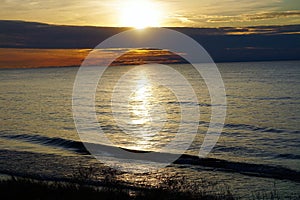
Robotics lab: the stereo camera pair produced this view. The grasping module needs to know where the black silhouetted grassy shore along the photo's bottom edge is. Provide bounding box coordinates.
[0,169,300,200]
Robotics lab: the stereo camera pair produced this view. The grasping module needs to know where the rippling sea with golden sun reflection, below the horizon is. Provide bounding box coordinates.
[0,61,300,196]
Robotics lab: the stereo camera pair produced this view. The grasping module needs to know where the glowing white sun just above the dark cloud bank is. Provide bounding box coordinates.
[120,0,162,29]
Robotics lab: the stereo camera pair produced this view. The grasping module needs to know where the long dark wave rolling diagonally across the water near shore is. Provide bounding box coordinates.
[0,134,300,182]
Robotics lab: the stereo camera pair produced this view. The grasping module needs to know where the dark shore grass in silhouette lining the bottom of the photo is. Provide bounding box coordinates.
[0,176,300,200]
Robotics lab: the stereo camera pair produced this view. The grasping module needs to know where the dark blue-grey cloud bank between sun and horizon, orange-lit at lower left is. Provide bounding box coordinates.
[0,20,300,63]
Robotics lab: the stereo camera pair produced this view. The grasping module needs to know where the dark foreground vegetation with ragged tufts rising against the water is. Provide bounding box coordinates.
[0,166,300,200]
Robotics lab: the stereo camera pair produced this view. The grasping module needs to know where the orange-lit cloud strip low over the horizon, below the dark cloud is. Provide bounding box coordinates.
[0,48,185,68]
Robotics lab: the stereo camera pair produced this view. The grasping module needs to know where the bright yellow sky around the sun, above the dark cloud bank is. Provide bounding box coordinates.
[0,0,300,28]
